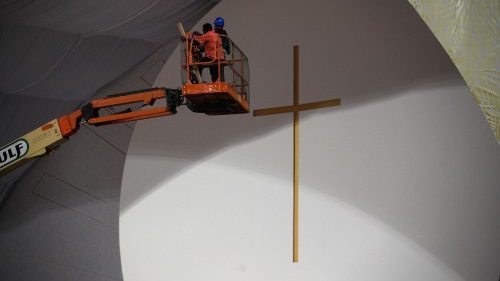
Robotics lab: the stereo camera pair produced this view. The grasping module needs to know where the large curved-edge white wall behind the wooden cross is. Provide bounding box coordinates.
[120,0,500,281]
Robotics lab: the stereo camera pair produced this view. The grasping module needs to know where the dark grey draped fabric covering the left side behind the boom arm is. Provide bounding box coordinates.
[0,0,217,281]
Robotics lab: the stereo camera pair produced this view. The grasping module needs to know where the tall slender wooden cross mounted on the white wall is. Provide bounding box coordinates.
[253,45,340,262]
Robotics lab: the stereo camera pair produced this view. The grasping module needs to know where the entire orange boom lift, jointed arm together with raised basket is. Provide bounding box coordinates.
[0,24,250,176]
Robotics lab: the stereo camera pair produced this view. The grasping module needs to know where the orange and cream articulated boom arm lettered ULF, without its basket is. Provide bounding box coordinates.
[0,88,183,176]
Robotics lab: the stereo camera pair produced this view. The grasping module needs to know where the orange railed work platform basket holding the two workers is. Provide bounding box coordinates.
[181,33,250,115]
